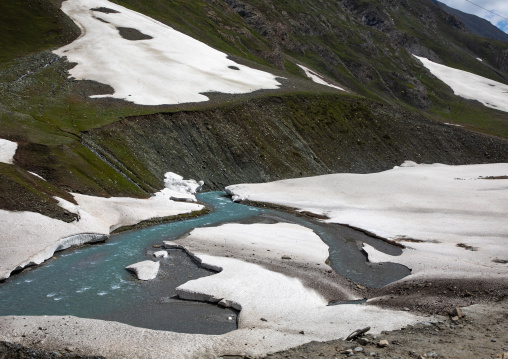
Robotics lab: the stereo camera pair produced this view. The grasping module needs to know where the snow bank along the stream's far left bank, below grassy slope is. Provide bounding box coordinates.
[0,178,203,278]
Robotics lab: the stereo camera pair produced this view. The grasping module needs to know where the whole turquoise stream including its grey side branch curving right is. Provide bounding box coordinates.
[0,192,410,334]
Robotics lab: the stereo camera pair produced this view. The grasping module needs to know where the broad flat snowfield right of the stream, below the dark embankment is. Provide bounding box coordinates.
[226,161,508,279]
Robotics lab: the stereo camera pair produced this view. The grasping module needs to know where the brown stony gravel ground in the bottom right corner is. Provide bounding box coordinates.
[254,300,508,359]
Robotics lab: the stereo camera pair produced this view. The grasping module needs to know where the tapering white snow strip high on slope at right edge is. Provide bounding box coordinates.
[413,55,508,112]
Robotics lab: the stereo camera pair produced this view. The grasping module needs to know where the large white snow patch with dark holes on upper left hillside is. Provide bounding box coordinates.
[55,0,280,105]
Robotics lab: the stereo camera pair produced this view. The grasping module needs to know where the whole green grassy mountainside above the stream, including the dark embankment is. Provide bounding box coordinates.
[0,0,508,219]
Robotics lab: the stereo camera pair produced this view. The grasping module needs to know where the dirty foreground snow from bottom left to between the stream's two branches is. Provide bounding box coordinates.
[0,223,429,359]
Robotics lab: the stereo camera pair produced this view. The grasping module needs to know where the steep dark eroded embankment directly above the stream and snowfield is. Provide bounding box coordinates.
[82,94,508,189]
